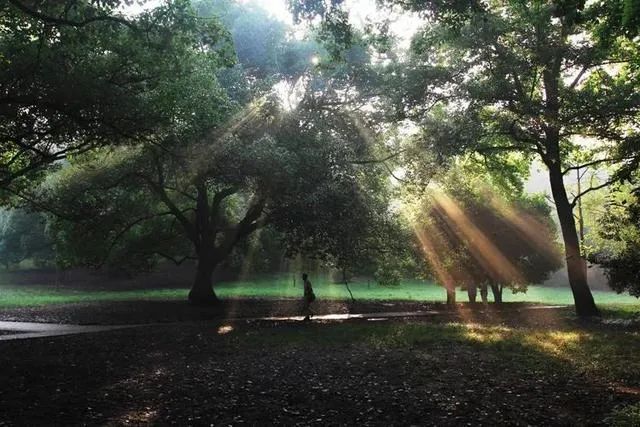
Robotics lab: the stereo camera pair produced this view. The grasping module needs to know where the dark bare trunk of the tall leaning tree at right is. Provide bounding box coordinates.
[547,162,600,316]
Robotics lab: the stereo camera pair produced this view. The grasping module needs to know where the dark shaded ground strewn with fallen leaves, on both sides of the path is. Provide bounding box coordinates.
[0,300,640,425]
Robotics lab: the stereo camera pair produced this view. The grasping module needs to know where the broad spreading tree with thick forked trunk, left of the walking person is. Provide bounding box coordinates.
[10,2,388,304]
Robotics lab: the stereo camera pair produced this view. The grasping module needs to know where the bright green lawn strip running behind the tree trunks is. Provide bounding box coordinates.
[0,278,640,312]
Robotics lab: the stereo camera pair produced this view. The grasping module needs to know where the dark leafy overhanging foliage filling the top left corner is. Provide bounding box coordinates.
[0,0,233,192]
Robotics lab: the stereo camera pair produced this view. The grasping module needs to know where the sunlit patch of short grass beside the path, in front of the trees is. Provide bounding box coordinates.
[239,322,640,387]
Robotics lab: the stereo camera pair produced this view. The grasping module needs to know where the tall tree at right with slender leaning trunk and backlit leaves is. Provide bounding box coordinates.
[293,0,640,316]
